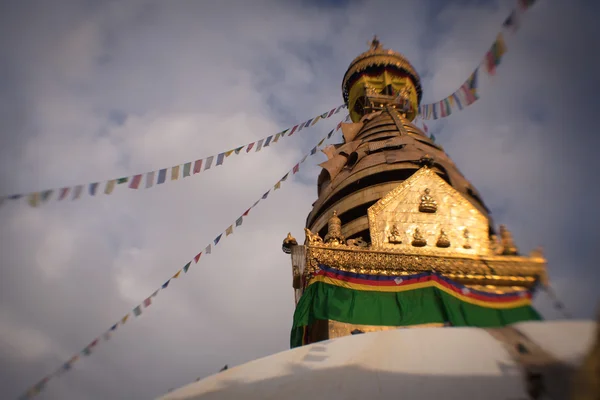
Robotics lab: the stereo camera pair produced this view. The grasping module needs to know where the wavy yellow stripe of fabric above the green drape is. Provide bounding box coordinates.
[308,275,531,309]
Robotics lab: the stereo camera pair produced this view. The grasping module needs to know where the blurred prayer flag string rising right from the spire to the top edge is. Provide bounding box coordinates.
[419,0,535,119]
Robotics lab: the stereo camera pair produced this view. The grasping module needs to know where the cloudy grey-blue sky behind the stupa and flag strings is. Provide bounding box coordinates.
[0,0,600,400]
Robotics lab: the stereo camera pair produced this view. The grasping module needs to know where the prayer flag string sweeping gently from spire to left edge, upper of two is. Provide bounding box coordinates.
[0,105,346,207]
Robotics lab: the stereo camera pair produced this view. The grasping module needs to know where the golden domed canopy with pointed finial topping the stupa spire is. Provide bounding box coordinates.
[342,36,423,104]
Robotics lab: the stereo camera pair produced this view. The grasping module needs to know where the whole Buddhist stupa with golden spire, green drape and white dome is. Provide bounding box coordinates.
[157,37,600,400]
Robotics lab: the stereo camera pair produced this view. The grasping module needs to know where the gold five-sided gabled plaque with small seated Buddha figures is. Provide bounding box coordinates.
[368,167,491,256]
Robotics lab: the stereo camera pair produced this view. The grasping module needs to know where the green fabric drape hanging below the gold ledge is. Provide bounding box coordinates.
[290,282,541,347]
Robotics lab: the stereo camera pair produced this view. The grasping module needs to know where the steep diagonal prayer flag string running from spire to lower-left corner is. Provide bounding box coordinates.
[19,115,350,400]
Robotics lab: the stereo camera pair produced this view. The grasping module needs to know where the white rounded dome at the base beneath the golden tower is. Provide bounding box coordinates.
[161,321,596,400]
